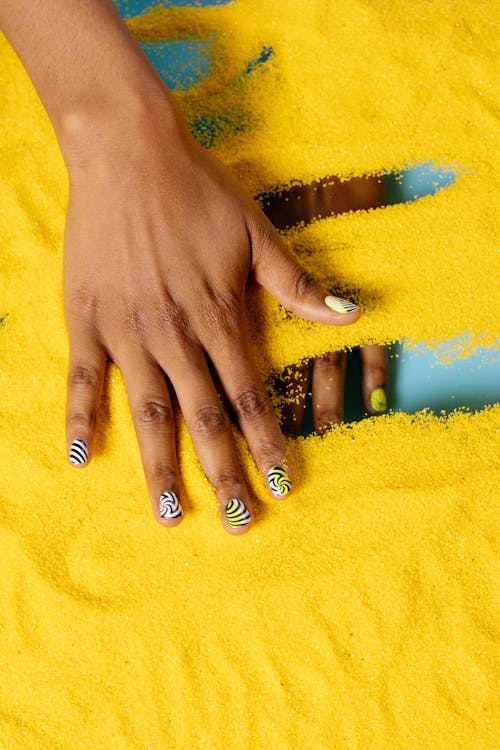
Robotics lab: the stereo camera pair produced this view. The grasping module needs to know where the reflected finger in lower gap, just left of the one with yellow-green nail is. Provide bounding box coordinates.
[312,351,347,432]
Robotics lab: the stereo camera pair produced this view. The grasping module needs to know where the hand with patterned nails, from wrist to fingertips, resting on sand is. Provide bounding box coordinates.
[64,98,359,534]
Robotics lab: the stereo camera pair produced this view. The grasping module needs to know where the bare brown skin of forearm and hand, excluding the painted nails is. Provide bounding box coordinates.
[0,0,360,534]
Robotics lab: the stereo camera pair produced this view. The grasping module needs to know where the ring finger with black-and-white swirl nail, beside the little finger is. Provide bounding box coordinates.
[117,351,183,526]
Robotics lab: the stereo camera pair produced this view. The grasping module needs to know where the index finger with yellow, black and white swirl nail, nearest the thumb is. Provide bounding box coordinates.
[201,330,292,499]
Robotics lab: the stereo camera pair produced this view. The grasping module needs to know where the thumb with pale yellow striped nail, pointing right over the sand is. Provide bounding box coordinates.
[253,226,361,326]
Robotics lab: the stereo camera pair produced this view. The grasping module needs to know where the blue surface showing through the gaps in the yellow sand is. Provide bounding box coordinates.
[114,0,500,422]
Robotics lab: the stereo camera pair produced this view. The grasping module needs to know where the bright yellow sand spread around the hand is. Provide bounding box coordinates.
[0,0,500,750]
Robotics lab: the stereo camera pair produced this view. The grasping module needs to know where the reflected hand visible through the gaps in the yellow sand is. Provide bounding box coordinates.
[260,177,387,437]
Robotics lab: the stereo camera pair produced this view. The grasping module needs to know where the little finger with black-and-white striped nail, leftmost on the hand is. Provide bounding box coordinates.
[66,329,106,466]
